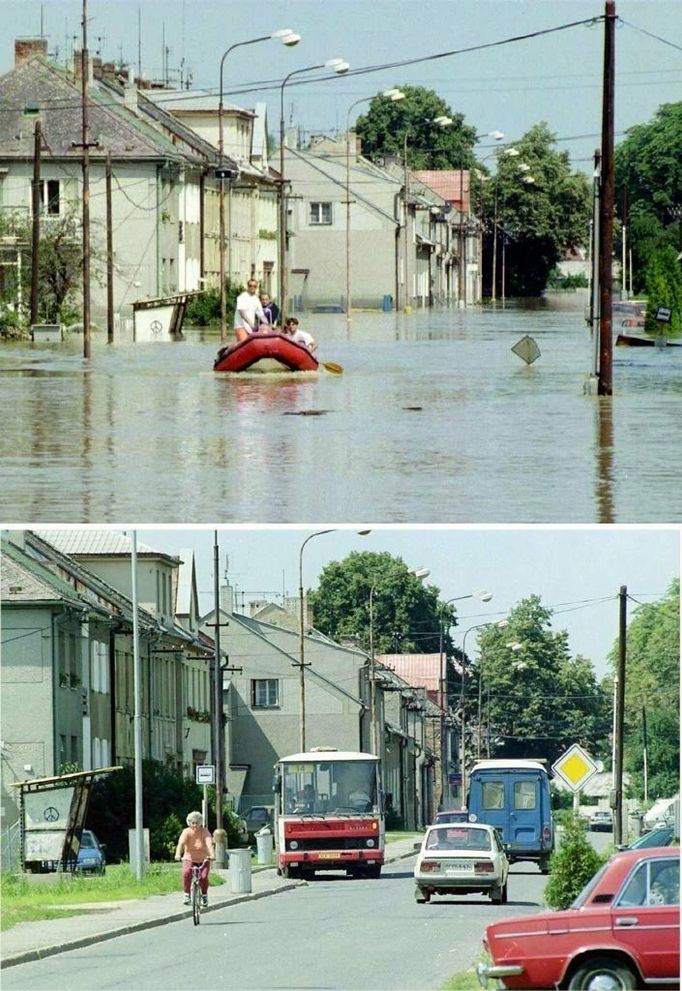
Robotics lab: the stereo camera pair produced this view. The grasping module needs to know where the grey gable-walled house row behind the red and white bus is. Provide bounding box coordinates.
[199,586,436,828]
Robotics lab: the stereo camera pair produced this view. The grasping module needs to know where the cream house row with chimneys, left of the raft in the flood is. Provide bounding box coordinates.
[0,39,277,318]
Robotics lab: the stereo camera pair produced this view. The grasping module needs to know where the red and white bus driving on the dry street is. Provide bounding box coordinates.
[274,747,385,877]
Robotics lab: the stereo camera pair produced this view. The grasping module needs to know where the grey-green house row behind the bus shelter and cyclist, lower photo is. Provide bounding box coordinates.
[1,531,214,860]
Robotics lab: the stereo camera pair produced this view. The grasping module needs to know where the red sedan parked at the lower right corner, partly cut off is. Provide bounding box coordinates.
[478,847,680,991]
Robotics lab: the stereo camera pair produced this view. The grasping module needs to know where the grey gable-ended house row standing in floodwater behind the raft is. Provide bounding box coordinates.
[276,131,480,311]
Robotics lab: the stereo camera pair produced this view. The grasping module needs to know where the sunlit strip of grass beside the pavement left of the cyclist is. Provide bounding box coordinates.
[0,864,223,930]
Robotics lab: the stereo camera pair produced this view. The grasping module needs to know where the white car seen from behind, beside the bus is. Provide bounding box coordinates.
[414,823,509,905]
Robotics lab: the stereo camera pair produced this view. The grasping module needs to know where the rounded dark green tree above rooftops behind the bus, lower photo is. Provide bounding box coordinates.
[308,551,455,654]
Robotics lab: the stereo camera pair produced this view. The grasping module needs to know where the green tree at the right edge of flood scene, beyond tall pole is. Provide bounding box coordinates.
[615,101,682,292]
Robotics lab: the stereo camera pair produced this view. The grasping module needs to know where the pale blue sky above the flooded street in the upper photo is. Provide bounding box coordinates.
[0,0,682,173]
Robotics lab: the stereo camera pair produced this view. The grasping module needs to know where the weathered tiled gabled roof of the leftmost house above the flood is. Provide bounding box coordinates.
[0,58,183,163]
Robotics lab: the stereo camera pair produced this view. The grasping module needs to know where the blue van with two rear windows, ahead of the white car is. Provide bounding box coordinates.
[468,760,554,874]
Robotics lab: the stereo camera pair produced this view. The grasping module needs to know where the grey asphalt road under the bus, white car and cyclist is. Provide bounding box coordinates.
[2,859,546,991]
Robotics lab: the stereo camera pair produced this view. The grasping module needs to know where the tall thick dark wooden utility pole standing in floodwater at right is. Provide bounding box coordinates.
[597,0,616,396]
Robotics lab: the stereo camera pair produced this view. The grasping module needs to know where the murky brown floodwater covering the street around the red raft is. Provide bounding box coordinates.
[0,306,682,524]
